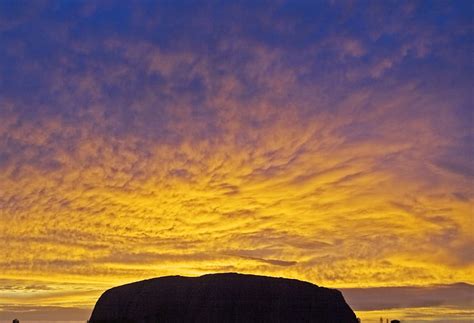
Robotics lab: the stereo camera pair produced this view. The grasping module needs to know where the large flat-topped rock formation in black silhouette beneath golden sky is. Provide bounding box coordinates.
[90,273,357,323]
